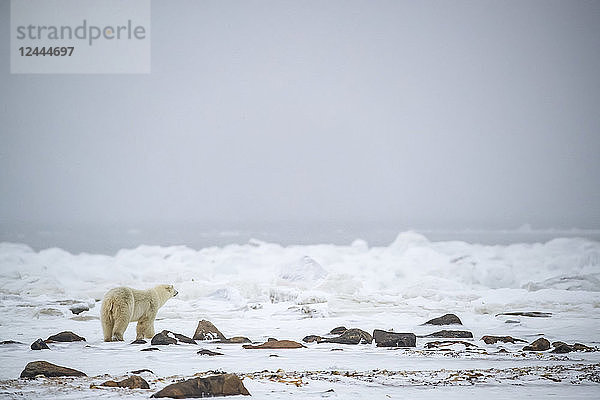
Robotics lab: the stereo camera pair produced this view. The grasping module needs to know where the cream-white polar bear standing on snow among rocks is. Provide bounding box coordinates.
[100,285,177,342]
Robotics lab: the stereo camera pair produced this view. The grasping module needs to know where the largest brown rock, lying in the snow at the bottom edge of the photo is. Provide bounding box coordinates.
[151,374,250,399]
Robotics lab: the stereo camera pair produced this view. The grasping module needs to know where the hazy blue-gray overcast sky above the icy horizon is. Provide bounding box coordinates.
[0,0,600,228]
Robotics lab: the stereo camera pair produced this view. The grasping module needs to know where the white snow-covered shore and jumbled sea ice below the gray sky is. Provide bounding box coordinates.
[0,227,600,399]
